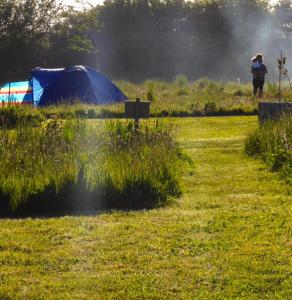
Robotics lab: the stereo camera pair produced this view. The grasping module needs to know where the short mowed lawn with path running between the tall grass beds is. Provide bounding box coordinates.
[0,117,292,299]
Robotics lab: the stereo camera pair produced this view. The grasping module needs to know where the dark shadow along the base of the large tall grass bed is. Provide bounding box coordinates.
[0,181,176,218]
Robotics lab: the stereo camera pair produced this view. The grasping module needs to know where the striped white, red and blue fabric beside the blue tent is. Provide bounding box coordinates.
[0,81,33,106]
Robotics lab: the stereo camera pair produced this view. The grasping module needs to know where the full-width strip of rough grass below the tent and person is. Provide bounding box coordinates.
[0,75,292,128]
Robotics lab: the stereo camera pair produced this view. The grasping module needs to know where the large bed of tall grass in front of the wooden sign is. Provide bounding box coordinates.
[0,119,183,213]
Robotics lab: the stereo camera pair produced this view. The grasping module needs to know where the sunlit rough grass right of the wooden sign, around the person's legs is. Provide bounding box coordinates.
[117,75,292,116]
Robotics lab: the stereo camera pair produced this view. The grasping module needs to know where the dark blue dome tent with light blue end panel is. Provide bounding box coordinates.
[30,66,127,106]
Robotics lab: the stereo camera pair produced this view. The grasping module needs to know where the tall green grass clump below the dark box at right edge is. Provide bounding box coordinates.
[245,113,292,183]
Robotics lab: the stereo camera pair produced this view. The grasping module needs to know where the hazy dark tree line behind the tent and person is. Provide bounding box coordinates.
[0,0,292,83]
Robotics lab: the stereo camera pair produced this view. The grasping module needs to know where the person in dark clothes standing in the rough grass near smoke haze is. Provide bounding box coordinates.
[251,54,268,97]
